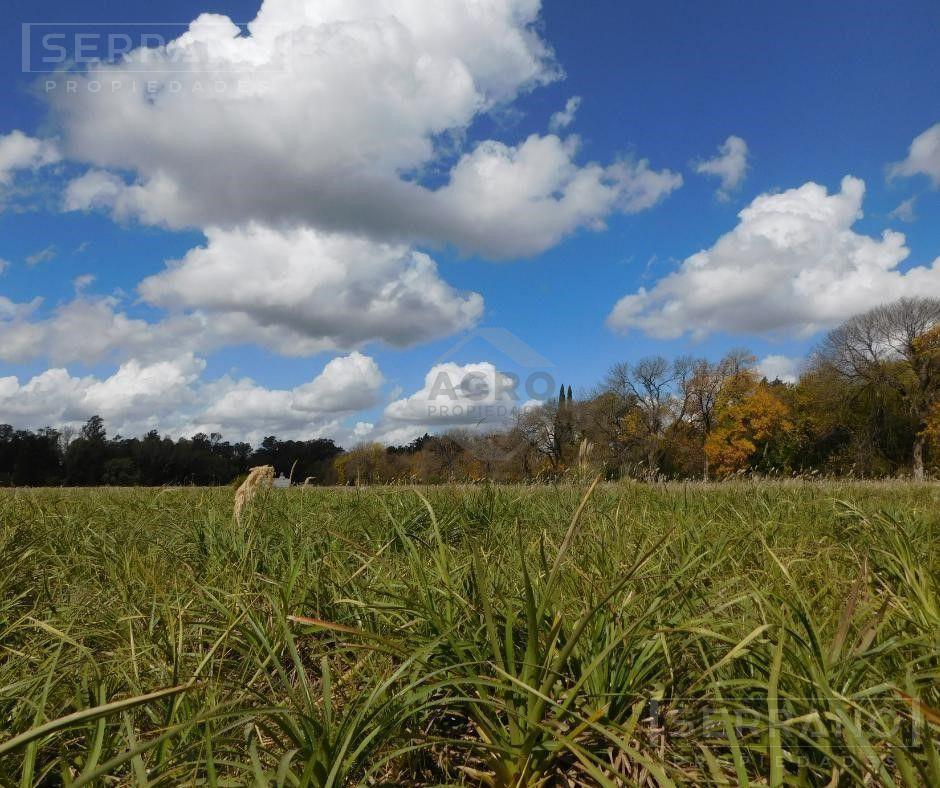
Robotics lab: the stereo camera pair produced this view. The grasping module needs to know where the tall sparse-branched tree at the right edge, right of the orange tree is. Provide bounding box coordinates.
[816,298,940,479]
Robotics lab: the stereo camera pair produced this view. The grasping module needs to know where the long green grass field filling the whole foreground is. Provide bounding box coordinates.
[0,482,940,786]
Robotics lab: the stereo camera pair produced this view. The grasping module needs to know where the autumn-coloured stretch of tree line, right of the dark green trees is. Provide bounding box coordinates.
[336,298,940,483]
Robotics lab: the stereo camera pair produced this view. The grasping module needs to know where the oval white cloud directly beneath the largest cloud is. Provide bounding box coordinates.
[139,224,483,355]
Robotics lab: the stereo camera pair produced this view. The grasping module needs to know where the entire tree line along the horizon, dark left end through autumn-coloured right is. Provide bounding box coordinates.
[0,298,940,485]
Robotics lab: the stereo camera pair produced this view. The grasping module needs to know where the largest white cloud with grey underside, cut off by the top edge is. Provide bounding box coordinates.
[50,0,681,258]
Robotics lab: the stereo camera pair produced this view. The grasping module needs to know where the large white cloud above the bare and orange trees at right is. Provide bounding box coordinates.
[607,176,940,338]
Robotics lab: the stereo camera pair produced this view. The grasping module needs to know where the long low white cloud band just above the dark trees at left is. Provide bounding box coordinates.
[0,353,383,444]
